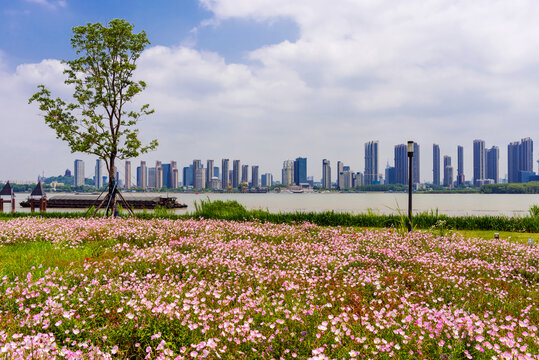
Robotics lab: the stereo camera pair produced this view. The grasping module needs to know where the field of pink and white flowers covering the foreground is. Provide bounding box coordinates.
[0,218,539,359]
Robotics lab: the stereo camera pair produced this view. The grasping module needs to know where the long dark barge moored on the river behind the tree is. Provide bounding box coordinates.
[20,193,187,209]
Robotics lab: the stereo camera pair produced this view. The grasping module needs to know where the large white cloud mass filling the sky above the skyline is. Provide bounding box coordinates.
[0,0,539,180]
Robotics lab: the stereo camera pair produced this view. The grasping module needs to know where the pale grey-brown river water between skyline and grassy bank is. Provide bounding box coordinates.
[9,192,539,216]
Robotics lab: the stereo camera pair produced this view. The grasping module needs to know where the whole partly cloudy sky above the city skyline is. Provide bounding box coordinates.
[0,0,539,182]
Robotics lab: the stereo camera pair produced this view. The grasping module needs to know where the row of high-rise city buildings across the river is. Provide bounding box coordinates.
[30,137,539,188]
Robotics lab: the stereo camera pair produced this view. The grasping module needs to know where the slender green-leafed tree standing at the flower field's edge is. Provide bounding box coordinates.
[29,19,158,215]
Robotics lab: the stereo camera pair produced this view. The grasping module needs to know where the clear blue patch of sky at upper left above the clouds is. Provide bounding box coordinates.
[0,0,298,68]
